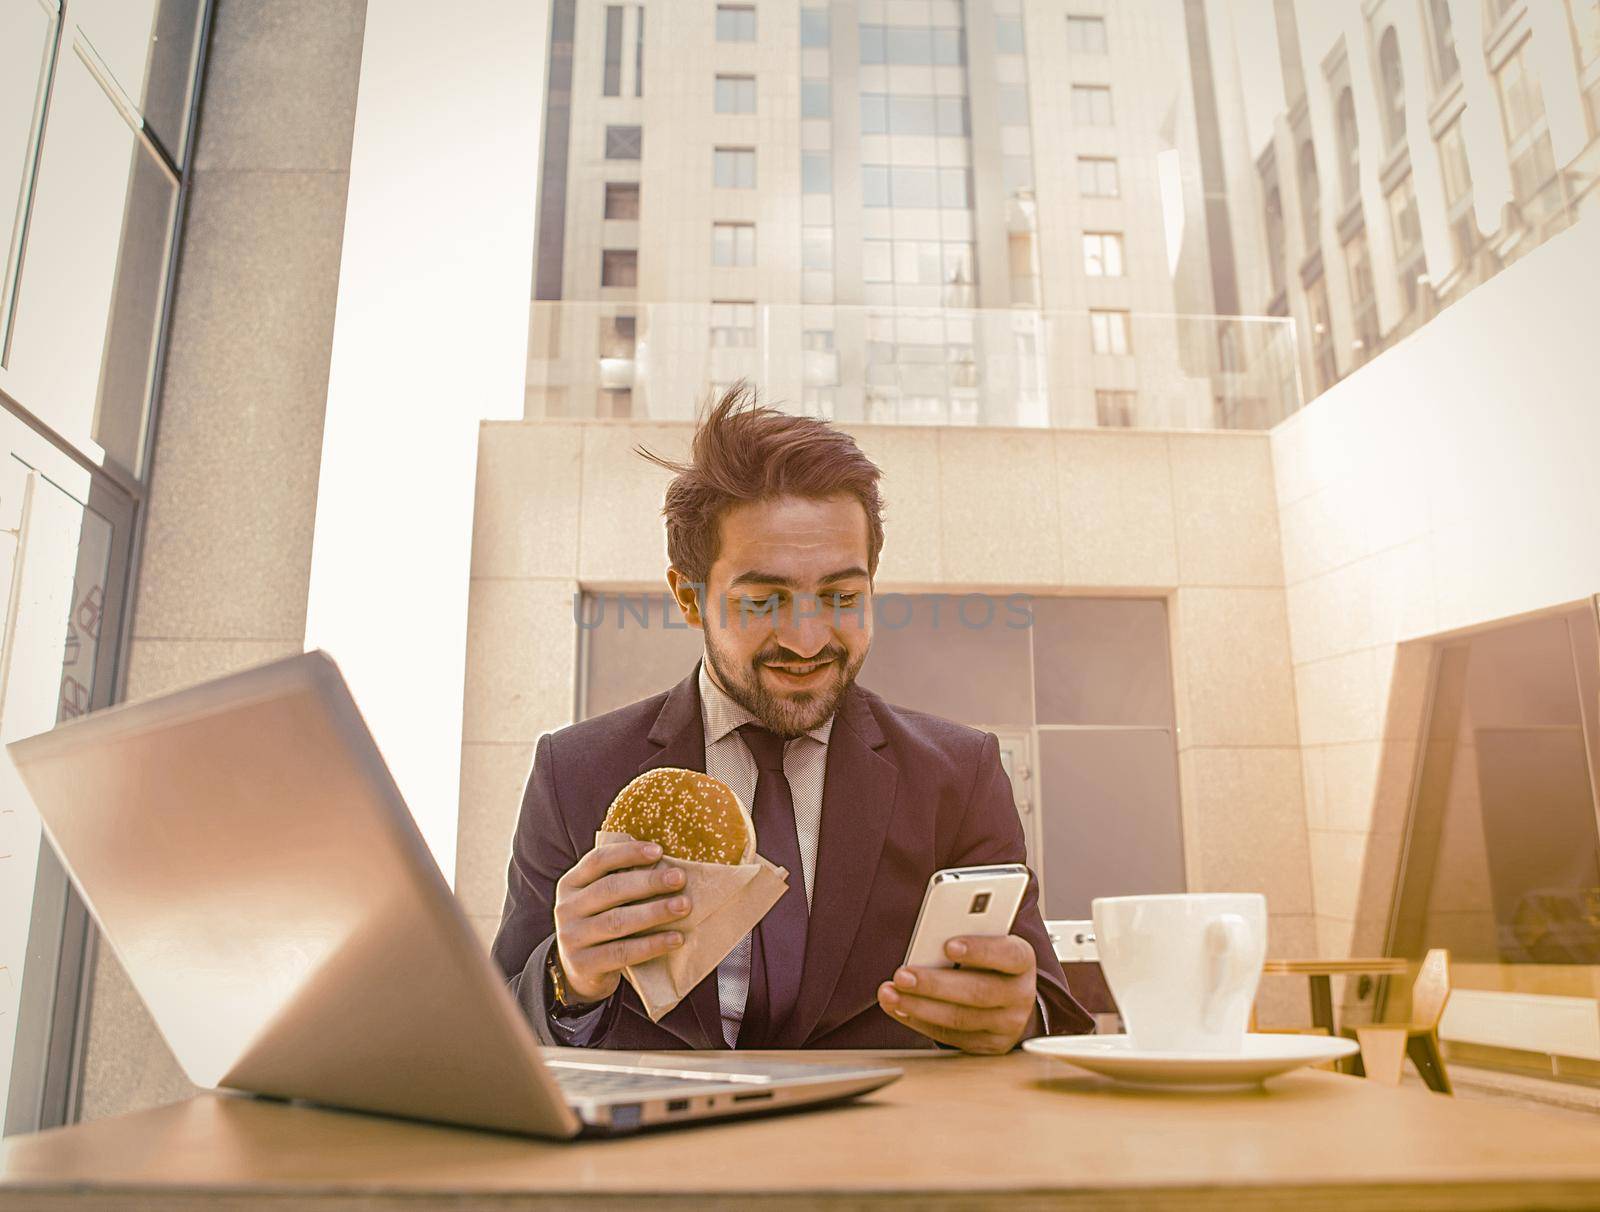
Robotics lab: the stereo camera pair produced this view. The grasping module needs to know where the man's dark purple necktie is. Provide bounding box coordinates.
[739,724,810,1047]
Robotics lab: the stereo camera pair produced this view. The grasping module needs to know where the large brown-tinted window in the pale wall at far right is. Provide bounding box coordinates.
[1395,608,1600,987]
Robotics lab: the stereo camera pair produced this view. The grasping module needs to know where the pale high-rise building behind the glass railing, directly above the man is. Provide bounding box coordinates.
[526,0,1299,427]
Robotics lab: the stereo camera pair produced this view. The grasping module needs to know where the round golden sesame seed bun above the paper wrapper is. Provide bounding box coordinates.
[602,766,755,865]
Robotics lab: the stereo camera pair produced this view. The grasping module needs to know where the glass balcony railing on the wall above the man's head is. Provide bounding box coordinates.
[526,302,1304,429]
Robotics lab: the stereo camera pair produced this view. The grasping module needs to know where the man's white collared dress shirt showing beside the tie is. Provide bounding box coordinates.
[699,660,834,1047]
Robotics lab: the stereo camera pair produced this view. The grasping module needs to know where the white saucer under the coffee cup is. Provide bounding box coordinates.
[1022,1035,1360,1090]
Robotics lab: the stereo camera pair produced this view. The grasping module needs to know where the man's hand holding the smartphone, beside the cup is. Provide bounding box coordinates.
[878,934,1038,1055]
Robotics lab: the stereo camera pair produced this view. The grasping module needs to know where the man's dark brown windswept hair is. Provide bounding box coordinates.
[634,379,883,585]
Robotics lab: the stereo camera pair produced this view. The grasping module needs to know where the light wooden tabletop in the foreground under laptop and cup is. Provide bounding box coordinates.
[0,1052,1600,1212]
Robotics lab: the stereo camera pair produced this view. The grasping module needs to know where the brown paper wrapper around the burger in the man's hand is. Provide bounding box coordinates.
[595,830,789,1022]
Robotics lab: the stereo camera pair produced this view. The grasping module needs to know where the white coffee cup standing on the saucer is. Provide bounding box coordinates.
[1091,892,1267,1052]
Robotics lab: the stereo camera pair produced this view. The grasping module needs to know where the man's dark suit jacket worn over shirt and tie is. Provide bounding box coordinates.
[493,668,1094,1051]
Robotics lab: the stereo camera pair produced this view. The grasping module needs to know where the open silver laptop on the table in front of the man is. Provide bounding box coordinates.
[6,652,899,1137]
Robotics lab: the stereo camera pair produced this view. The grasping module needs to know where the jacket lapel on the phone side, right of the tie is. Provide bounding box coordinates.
[778,688,899,1047]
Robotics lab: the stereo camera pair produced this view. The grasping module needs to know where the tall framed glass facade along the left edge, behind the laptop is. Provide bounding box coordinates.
[0,0,208,1132]
